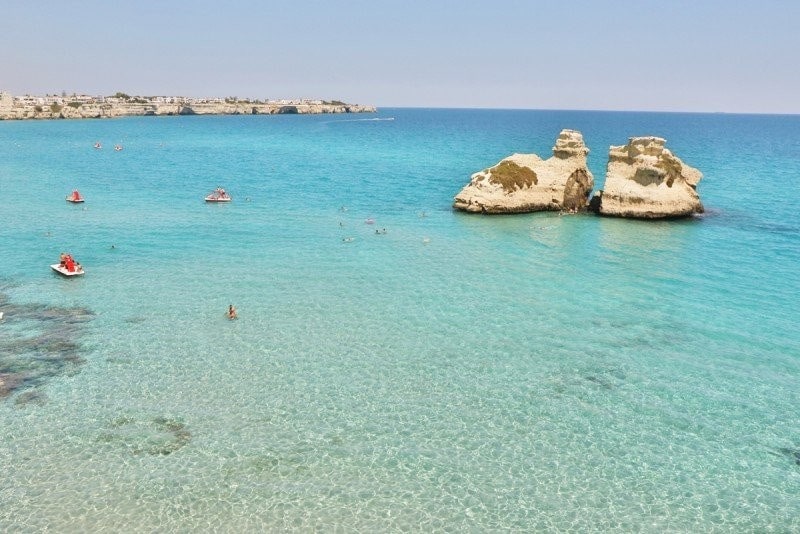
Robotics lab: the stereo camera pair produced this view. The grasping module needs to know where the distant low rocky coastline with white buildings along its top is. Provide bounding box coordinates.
[0,92,377,120]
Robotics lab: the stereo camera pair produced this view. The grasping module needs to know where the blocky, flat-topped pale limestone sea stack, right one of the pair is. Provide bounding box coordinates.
[590,137,703,219]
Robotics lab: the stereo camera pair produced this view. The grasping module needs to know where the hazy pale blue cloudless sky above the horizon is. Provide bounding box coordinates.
[0,0,800,114]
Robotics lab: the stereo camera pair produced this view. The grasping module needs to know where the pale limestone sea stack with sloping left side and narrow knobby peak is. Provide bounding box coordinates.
[453,130,594,213]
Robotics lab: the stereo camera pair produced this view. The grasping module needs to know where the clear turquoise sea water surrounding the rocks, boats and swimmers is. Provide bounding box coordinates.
[0,109,800,532]
